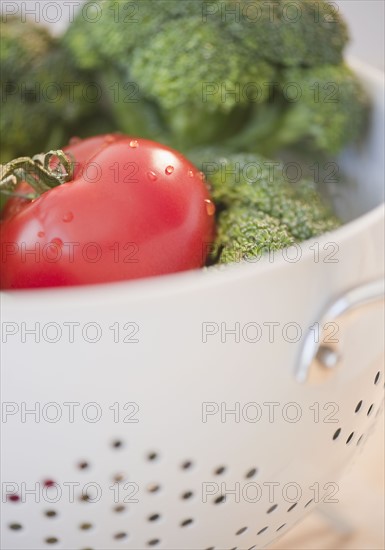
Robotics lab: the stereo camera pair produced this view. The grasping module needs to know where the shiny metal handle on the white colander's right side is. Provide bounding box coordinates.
[295,279,385,383]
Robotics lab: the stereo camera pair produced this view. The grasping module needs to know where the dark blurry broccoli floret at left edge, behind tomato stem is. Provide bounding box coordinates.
[0,17,97,162]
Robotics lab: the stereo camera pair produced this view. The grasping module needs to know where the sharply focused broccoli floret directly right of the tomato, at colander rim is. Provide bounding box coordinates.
[199,153,340,262]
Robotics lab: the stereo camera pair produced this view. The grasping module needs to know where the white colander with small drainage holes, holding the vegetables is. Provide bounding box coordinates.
[1,62,384,550]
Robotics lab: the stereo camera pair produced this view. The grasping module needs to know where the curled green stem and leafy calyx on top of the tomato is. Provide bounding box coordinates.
[0,149,73,196]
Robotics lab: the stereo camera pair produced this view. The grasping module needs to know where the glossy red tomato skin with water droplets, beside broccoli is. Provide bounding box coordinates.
[1,135,214,289]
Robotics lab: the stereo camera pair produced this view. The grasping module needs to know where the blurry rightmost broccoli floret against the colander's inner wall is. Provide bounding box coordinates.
[224,64,370,156]
